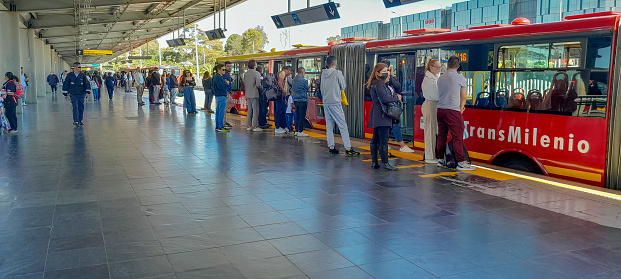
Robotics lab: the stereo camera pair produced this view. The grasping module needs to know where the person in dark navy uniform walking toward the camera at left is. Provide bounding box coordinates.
[63,62,91,126]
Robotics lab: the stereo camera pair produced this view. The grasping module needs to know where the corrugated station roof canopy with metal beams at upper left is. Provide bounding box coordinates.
[5,0,246,63]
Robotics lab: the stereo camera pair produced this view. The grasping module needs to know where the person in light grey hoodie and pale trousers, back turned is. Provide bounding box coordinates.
[321,56,360,156]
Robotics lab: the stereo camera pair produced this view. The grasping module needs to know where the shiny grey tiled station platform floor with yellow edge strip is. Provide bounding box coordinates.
[0,92,621,279]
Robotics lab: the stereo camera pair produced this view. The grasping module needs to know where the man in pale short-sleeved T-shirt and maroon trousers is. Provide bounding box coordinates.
[436,56,476,171]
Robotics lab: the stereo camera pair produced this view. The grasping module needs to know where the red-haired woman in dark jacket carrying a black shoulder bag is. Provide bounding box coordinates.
[366,63,401,171]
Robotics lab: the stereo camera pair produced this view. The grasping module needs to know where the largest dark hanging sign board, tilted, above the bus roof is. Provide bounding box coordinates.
[272,2,341,28]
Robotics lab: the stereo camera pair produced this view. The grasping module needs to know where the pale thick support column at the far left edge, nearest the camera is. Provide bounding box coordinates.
[0,11,21,80]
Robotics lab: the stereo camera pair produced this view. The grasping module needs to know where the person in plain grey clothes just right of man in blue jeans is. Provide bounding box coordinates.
[244,59,263,132]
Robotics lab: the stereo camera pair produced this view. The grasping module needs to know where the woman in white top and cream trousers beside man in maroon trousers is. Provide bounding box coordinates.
[421,59,442,164]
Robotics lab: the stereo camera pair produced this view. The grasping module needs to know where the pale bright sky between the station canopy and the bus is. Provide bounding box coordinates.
[158,0,465,50]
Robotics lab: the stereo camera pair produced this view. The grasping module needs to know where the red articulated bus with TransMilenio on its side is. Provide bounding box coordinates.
[218,12,621,189]
